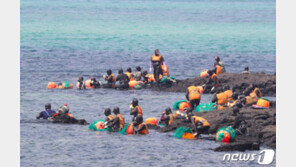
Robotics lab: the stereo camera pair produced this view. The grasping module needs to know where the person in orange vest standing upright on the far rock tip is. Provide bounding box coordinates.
[150,49,166,87]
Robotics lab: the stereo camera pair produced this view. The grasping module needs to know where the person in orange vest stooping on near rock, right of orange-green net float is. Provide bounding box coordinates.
[185,108,210,137]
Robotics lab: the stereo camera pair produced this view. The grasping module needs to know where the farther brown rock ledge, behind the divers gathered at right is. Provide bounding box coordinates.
[152,73,276,96]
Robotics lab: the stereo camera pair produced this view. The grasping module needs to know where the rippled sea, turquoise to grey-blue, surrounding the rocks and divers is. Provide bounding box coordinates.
[20,0,276,166]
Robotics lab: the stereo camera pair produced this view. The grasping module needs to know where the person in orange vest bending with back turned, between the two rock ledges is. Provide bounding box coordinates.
[185,85,201,110]
